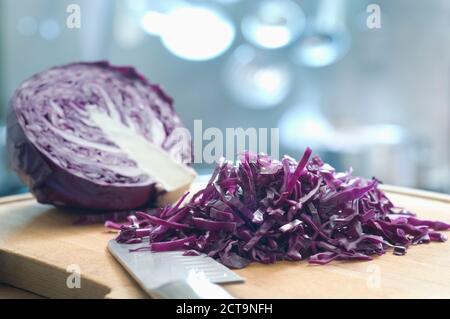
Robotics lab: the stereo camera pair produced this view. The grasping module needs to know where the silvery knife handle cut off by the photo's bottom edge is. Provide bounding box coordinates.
[152,280,234,299]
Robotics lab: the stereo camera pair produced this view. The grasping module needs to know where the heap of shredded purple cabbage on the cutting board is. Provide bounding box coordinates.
[106,148,450,268]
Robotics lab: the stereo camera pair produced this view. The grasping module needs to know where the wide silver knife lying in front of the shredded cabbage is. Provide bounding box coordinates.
[108,239,244,299]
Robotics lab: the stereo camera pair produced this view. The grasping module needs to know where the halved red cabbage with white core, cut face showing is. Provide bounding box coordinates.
[7,62,195,210]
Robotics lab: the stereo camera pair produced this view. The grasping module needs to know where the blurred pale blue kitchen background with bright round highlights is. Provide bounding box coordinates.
[0,0,450,195]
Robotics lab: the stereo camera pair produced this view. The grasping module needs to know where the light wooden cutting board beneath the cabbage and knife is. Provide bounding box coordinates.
[0,187,450,298]
